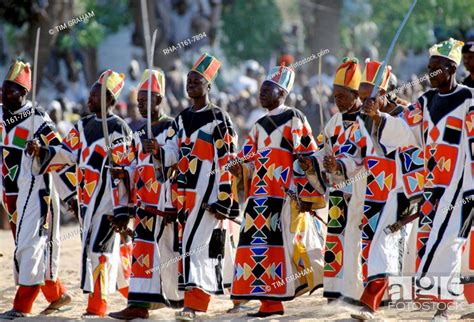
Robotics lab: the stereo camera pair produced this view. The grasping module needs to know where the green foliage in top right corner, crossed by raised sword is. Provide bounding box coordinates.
[341,0,474,55]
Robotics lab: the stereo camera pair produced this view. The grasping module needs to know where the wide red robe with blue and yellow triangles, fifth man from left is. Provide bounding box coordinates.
[231,106,325,301]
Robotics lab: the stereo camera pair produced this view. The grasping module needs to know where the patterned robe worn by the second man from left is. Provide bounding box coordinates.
[35,113,134,296]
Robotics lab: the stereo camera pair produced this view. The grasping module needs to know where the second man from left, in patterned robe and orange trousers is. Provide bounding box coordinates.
[30,70,134,317]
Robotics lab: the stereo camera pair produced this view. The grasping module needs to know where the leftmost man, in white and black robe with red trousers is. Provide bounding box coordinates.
[0,61,71,319]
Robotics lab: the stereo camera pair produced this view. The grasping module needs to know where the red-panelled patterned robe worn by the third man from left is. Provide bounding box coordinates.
[128,116,183,308]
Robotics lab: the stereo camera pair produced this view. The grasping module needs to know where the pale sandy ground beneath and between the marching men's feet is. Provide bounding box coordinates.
[0,226,474,321]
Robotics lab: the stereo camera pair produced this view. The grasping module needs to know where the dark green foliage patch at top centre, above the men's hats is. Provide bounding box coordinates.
[221,0,282,64]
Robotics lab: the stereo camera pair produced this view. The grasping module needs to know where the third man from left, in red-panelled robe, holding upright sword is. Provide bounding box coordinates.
[110,69,183,320]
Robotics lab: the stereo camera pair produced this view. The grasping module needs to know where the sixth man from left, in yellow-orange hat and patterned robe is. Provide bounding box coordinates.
[302,58,366,303]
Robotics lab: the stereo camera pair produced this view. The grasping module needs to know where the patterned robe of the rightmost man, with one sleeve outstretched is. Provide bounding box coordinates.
[379,85,474,298]
